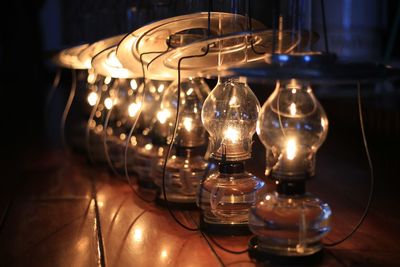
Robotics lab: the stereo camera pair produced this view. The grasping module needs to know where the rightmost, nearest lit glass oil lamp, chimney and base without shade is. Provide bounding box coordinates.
[249,79,331,257]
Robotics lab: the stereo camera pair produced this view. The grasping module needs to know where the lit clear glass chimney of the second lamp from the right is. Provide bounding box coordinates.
[201,77,260,161]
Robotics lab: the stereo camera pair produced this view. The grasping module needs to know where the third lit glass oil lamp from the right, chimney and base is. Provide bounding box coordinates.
[154,78,210,208]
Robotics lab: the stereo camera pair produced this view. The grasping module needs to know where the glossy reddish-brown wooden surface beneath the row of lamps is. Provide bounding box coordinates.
[0,132,400,267]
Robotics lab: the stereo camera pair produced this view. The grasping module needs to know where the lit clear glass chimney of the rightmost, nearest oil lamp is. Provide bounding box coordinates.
[257,79,328,180]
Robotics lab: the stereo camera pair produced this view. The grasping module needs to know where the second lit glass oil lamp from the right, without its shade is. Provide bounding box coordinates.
[197,78,264,234]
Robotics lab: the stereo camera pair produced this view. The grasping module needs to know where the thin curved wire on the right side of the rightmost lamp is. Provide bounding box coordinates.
[323,82,375,247]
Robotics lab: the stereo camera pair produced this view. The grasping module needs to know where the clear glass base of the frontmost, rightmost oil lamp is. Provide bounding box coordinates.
[249,192,331,257]
